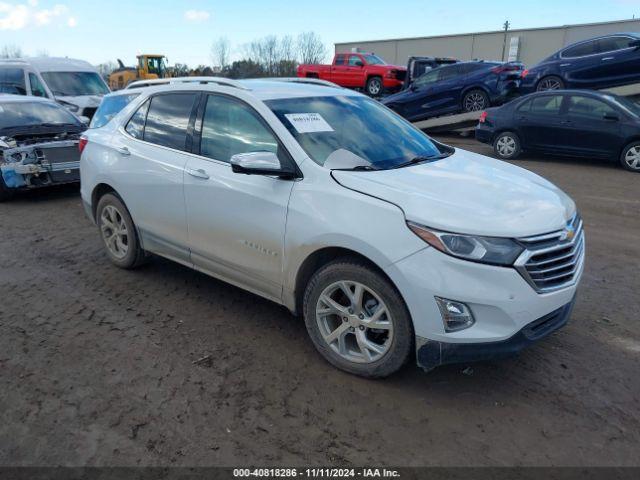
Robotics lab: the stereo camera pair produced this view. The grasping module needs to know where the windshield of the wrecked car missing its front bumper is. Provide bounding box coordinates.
[0,102,81,129]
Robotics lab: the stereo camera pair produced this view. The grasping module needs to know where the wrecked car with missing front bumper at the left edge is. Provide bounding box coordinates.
[0,95,87,201]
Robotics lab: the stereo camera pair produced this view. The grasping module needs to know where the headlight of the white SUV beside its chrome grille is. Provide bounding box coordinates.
[407,222,524,265]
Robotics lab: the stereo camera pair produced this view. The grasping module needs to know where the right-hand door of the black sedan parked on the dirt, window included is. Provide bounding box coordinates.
[557,95,624,157]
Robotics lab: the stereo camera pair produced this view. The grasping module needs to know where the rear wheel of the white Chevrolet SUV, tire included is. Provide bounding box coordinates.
[96,193,145,270]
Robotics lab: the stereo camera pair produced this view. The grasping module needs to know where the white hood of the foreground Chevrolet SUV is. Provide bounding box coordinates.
[332,149,576,238]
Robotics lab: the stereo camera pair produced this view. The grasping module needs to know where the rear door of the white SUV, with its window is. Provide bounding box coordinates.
[112,92,199,263]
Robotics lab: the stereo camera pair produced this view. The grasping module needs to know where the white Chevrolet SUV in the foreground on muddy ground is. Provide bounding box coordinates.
[81,79,584,377]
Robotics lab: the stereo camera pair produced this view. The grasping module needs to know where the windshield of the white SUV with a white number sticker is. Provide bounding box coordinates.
[265,96,440,169]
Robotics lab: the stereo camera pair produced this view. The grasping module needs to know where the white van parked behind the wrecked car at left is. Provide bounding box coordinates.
[0,57,109,118]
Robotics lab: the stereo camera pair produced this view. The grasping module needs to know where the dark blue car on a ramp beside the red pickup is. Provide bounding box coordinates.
[382,61,523,122]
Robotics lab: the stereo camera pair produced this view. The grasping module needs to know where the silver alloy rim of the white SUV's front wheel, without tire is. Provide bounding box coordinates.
[316,281,393,363]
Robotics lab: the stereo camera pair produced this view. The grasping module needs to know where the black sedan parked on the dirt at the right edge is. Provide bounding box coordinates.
[476,90,640,172]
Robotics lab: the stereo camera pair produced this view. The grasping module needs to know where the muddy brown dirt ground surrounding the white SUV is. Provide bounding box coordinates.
[0,137,640,466]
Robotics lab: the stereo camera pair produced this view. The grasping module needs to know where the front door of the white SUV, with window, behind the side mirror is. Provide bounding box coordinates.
[185,94,294,300]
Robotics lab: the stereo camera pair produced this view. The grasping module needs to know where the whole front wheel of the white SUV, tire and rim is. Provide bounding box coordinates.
[303,258,414,378]
